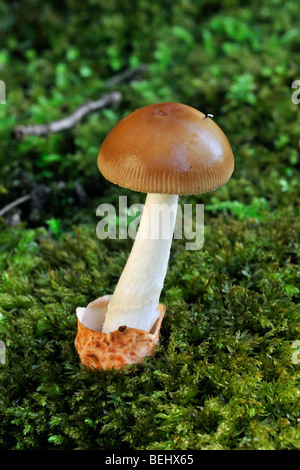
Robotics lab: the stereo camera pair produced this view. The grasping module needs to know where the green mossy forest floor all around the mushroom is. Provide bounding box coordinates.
[0,0,300,451]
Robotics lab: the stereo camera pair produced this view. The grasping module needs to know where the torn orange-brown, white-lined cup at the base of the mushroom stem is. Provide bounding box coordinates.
[75,295,166,369]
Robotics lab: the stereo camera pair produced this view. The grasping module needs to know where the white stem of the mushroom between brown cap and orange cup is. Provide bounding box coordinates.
[102,194,178,333]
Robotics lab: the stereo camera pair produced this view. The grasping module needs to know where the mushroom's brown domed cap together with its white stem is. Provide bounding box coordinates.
[75,103,234,370]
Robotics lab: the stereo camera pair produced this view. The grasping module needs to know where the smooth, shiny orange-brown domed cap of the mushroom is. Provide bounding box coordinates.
[98,103,234,195]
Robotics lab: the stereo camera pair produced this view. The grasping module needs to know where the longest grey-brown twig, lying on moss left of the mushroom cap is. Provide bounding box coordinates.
[14,91,122,139]
